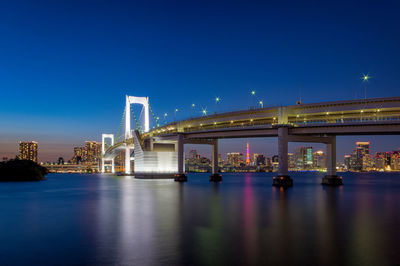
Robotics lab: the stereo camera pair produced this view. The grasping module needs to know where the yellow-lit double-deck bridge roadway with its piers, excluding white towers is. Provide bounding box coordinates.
[101,97,400,186]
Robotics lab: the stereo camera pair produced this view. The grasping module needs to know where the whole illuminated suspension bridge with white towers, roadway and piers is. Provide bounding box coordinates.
[102,95,400,186]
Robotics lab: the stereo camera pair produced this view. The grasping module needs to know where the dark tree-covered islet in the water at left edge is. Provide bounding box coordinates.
[0,159,48,182]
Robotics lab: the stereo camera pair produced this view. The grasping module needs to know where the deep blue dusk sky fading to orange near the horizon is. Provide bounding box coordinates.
[0,0,400,161]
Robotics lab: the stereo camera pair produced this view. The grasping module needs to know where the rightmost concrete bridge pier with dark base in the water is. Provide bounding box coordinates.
[322,136,343,186]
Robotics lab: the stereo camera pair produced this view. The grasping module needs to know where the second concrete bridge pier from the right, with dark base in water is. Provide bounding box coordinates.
[272,126,293,187]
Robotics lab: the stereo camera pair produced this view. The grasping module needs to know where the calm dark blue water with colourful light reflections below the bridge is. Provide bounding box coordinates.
[0,173,400,265]
